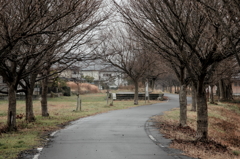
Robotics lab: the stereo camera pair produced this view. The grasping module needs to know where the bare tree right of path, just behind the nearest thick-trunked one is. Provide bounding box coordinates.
[115,0,192,126]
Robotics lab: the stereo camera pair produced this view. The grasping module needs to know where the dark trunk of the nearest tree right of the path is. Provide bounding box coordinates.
[196,80,208,140]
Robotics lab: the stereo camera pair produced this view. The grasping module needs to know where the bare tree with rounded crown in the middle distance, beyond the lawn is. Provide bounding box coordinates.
[98,26,166,105]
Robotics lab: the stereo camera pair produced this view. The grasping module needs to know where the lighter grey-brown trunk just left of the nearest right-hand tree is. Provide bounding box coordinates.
[179,84,187,127]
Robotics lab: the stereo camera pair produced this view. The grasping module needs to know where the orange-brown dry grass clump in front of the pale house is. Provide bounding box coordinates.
[67,82,99,94]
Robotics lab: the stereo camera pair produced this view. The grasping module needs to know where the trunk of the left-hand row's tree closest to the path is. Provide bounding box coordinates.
[41,77,49,117]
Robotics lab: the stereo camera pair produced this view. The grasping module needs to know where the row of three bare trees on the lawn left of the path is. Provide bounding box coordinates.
[0,0,109,131]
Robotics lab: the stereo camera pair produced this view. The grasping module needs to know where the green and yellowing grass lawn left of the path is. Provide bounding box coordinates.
[0,93,162,159]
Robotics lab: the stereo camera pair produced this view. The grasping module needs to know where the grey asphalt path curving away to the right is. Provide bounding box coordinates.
[39,94,192,159]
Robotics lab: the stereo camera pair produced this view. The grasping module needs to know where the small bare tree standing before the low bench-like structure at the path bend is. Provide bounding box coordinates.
[101,26,160,105]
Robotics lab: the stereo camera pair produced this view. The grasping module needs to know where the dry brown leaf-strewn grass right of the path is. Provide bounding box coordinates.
[154,104,240,159]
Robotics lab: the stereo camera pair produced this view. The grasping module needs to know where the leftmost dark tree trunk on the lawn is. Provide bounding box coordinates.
[7,85,17,131]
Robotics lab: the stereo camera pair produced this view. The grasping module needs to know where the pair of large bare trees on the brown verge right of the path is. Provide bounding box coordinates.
[110,0,240,140]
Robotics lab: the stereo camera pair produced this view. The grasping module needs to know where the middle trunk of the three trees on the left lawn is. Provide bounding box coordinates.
[25,88,35,122]
